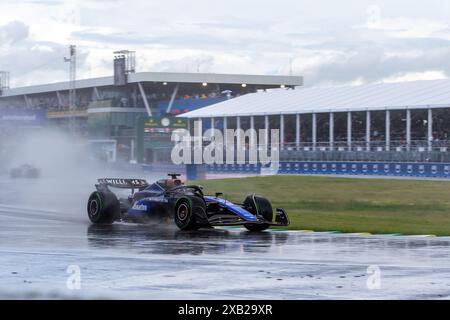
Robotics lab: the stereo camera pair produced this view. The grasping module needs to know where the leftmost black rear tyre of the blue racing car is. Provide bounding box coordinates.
[87,191,120,224]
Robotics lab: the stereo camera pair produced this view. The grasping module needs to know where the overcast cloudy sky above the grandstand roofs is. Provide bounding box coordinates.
[0,0,450,86]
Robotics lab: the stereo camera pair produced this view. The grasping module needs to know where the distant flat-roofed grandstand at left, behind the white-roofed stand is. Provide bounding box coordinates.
[0,71,303,162]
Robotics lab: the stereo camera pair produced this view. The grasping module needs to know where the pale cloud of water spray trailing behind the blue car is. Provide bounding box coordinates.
[6,129,114,219]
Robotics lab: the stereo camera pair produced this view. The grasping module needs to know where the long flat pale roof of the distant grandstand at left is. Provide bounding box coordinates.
[0,72,303,98]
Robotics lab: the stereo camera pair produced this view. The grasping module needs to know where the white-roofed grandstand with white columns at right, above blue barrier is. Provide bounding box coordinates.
[183,80,450,163]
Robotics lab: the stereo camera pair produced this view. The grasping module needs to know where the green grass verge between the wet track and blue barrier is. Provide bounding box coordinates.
[195,176,450,235]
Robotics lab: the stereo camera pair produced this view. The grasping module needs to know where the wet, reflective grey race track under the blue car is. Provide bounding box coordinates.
[0,172,450,299]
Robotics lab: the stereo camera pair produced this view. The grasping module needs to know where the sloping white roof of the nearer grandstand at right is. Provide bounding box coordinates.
[180,80,450,118]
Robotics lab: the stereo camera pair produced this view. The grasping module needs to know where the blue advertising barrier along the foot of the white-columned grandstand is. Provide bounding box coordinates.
[206,161,450,178]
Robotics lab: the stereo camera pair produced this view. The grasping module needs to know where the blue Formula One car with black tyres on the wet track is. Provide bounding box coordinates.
[87,174,289,231]
